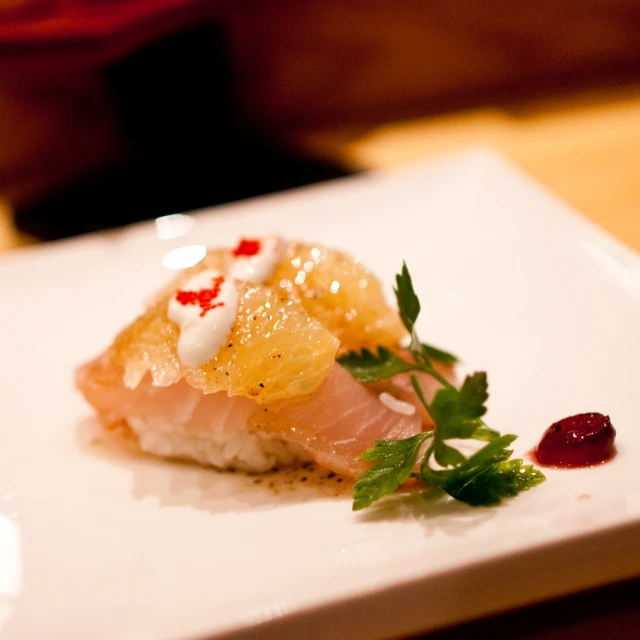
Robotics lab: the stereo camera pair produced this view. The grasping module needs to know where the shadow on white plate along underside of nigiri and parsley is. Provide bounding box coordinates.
[77,417,496,536]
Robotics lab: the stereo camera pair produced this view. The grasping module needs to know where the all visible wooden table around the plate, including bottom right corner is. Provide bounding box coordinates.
[0,84,640,640]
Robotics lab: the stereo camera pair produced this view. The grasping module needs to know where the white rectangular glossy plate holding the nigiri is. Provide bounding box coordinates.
[0,150,640,640]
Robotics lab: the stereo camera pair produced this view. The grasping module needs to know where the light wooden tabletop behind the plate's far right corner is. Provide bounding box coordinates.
[301,83,640,251]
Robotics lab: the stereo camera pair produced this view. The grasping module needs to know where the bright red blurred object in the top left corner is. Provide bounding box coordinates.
[0,0,220,73]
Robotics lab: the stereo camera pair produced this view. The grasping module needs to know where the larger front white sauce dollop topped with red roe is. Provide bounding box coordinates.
[167,269,238,368]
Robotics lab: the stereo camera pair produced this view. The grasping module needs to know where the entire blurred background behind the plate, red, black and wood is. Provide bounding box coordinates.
[0,0,640,247]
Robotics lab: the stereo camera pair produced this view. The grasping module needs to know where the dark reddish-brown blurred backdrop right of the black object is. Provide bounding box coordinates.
[225,0,640,130]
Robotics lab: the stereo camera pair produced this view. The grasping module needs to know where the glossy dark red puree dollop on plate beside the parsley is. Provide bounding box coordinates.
[533,413,616,468]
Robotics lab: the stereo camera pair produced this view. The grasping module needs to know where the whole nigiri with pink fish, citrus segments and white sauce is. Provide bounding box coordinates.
[76,236,452,477]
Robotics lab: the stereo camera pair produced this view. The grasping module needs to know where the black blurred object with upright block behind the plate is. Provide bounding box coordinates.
[7,25,347,240]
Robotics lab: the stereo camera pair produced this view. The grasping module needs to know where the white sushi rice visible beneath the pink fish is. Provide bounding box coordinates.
[128,417,311,473]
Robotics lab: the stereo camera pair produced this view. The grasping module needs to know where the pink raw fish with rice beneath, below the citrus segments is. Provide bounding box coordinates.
[76,356,422,477]
